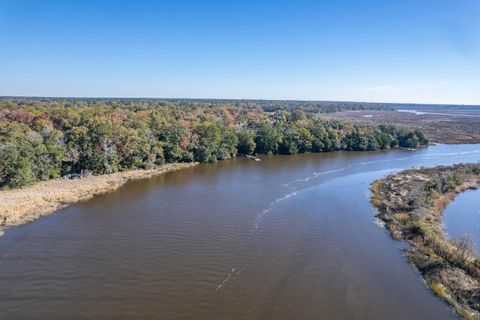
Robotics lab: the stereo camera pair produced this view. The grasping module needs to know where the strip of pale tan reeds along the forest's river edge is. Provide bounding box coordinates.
[0,162,198,231]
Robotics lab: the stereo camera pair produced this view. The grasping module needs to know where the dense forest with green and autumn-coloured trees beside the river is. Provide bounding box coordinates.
[0,99,427,188]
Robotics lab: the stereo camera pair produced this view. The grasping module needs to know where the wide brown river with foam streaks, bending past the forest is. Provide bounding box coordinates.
[0,145,480,320]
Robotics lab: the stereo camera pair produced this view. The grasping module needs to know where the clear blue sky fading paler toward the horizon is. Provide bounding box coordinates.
[0,0,480,104]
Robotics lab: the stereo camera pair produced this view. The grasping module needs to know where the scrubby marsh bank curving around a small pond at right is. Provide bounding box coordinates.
[371,164,480,319]
